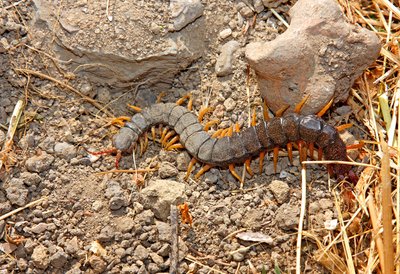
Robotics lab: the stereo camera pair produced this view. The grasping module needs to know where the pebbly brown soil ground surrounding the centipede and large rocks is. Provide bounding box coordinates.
[0,0,364,273]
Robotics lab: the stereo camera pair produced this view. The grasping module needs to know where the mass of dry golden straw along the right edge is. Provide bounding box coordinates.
[303,0,400,273]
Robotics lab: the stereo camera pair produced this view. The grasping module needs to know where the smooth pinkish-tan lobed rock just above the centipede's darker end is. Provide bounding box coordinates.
[246,0,380,114]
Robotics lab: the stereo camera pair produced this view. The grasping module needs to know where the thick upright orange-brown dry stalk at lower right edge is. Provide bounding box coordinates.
[381,134,394,273]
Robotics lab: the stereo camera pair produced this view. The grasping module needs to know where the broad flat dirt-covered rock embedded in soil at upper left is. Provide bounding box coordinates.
[32,0,206,93]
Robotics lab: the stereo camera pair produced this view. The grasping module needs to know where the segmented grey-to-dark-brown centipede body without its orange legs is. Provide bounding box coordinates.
[113,103,350,176]
